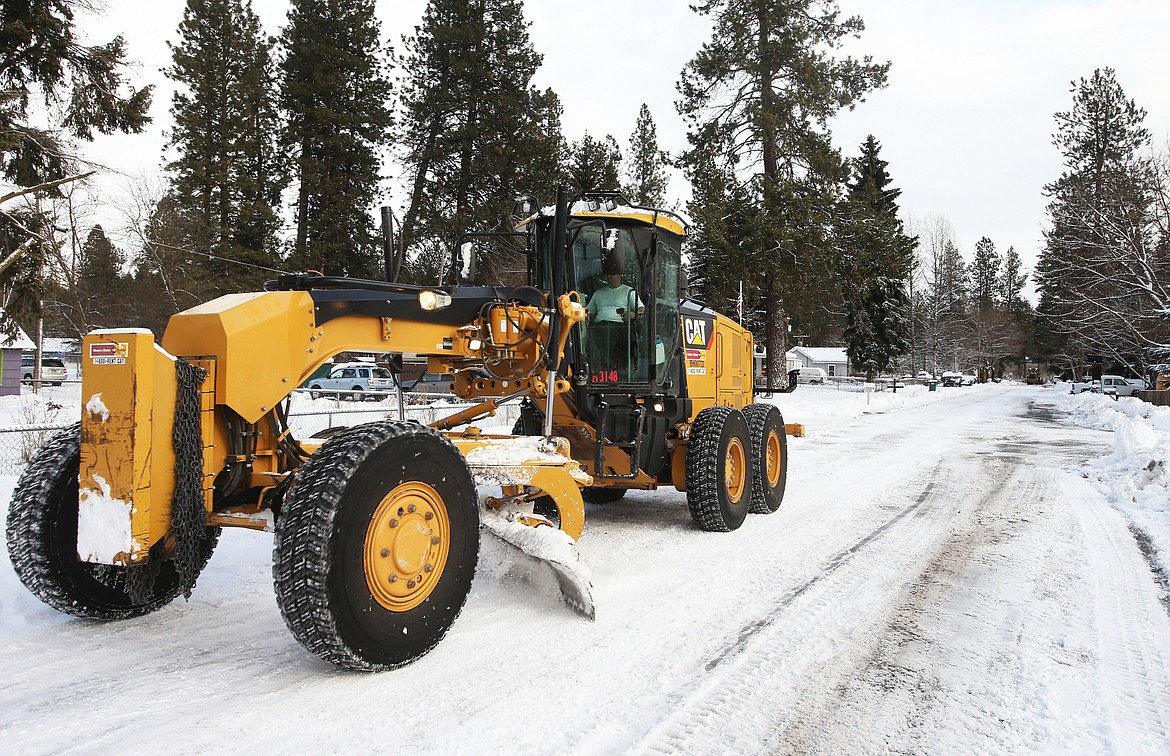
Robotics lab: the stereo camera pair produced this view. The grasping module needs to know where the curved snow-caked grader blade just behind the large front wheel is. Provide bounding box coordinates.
[481,508,597,620]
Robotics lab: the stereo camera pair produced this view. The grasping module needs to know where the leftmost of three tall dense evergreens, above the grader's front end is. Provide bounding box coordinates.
[166,0,285,293]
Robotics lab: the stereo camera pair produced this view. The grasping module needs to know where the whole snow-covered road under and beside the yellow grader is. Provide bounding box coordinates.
[0,386,1170,754]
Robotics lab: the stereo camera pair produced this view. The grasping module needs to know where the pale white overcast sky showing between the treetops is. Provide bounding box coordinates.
[81,0,1170,293]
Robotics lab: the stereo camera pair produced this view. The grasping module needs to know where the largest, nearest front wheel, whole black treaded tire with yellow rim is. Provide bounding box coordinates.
[273,421,480,672]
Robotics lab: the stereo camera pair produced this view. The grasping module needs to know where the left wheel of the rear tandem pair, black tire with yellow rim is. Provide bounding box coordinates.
[687,407,752,532]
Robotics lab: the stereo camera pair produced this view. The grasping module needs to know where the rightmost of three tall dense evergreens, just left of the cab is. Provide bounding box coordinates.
[397,0,564,280]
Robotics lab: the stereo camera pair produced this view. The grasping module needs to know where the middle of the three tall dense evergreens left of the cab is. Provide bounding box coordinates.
[281,0,392,277]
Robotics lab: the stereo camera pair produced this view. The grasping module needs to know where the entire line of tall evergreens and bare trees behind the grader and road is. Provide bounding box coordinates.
[9,0,1170,386]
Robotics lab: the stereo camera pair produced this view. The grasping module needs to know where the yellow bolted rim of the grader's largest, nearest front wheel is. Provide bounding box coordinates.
[364,481,450,612]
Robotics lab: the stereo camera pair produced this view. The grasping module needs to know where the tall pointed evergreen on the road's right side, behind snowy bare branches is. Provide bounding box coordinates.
[1035,68,1168,369]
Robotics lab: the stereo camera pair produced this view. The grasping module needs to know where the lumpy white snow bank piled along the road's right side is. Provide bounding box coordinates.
[1053,392,1170,580]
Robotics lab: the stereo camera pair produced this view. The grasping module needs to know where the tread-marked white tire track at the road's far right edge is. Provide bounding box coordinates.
[1073,496,1170,754]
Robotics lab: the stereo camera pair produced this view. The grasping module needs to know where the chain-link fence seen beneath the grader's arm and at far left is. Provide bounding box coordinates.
[0,394,519,475]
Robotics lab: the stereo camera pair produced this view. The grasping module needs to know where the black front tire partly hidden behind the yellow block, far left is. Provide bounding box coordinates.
[7,426,219,619]
